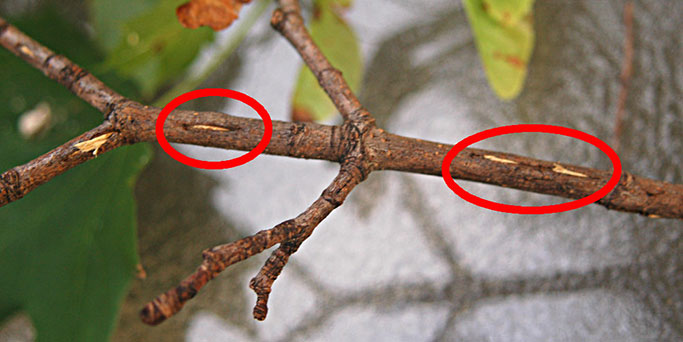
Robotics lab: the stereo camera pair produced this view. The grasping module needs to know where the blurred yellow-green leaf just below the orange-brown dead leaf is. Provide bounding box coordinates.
[99,0,214,99]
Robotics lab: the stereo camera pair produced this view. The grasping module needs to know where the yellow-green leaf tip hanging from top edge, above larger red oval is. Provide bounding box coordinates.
[464,0,534,100]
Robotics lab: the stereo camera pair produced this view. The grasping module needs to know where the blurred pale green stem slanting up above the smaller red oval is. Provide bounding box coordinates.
[154,0,270,107]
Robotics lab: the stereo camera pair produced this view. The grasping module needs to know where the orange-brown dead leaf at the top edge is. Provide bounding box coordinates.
[176,0,251,31]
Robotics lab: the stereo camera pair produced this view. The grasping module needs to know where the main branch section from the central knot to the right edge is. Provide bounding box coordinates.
[374,133,683,219]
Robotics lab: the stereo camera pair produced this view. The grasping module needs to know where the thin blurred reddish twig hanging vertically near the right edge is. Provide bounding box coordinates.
[612,1,633,152]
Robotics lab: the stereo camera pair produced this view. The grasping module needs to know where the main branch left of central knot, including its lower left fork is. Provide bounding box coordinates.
[0,101,343,207]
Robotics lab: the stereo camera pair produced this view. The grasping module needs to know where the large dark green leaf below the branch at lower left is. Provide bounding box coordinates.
[0,148,146,341]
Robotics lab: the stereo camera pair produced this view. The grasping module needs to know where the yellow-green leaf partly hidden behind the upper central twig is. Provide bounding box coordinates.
[292,0,363,121]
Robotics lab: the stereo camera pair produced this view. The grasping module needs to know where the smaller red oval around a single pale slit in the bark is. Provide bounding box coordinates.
[156,88,273,170]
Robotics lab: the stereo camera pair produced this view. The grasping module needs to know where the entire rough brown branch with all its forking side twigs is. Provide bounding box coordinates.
[0,0,683,324]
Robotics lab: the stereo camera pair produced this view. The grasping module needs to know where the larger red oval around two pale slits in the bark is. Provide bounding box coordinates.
[441,124,621,214]
